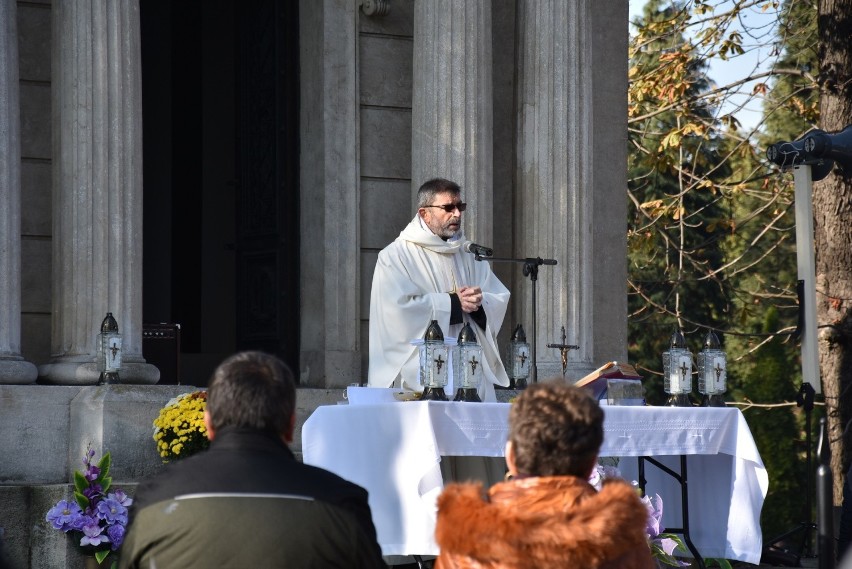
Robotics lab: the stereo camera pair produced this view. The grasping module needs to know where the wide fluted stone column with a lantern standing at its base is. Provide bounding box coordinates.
[39,0,160,385]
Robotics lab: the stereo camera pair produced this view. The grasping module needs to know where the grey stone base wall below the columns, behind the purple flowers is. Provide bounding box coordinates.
[0,385,343,569]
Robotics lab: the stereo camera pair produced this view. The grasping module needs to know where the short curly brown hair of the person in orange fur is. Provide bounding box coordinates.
[509,380,604,477]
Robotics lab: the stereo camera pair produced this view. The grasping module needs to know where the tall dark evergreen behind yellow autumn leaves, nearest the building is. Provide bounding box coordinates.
[628,0,731,403]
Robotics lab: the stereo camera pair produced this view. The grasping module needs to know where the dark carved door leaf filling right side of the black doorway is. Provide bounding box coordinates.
[236,0,299,377]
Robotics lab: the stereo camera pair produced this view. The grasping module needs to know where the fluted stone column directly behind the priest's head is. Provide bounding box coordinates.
[411,0,494,242]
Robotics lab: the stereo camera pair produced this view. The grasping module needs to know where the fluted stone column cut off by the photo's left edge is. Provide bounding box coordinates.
[0,0,38,384]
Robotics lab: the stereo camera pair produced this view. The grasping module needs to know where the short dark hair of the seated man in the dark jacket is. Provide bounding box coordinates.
[207,352,296,435]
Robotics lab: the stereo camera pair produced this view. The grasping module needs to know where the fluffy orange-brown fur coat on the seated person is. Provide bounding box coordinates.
[435,476,656,569]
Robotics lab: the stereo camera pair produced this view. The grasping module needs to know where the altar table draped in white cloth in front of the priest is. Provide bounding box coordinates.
[302,401,769,564]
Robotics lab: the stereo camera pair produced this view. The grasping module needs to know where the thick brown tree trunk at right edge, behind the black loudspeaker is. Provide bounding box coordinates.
[811,0,852,504]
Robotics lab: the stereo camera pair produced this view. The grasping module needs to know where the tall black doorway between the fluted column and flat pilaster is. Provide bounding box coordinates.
[140,0,299,385]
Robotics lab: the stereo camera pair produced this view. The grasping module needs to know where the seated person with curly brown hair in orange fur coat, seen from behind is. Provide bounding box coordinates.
[435,382,655,569]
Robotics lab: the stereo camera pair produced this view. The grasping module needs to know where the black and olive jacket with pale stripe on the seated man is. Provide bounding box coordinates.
[119,428,386,569]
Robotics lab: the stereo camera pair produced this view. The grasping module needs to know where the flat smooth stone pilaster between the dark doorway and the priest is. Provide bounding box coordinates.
[299,0,362,387]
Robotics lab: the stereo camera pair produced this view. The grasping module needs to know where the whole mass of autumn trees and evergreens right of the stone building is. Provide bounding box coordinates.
[628,0,819,544]
